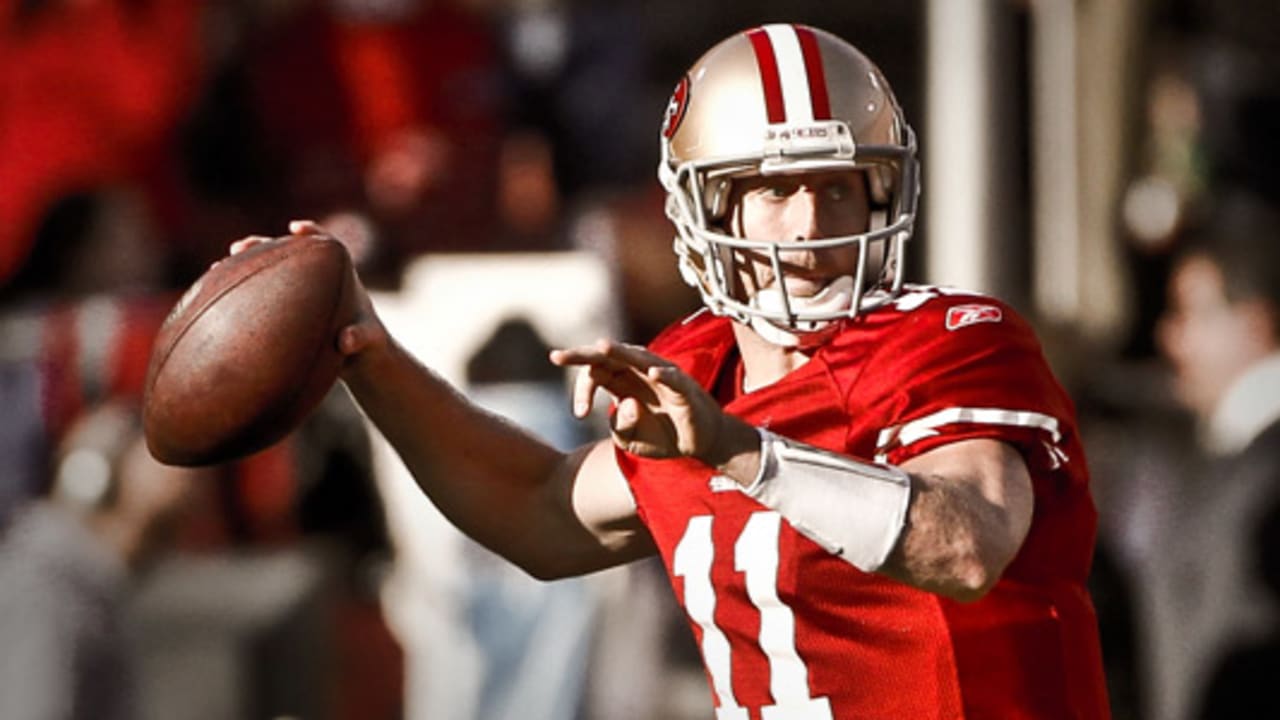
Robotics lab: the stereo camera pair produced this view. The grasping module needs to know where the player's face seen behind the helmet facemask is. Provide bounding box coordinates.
[731,170,870,300]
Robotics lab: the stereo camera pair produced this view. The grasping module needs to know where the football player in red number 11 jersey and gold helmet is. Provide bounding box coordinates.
[249,24,1108,720]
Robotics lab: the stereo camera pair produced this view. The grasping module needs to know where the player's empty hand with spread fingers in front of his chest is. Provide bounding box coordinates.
[550,340,730,462]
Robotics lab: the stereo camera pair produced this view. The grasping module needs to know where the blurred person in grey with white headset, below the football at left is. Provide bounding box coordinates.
[0,404,207,720]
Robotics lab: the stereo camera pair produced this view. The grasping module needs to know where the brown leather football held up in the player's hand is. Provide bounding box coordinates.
[142,236,356,465]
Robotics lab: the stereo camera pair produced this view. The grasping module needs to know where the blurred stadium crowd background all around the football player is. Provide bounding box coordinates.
[0,0,1280,720]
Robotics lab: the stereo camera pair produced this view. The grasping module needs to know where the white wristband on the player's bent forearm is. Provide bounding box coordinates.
[744,429,911,573]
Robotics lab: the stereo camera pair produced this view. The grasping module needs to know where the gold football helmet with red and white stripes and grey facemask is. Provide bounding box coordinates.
[658,26,918,346]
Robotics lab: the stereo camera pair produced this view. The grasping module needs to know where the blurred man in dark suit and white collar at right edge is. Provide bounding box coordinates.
[1142,192,1280,720]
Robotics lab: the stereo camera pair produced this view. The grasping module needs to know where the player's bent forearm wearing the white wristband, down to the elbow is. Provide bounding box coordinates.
[701,416,1030,601]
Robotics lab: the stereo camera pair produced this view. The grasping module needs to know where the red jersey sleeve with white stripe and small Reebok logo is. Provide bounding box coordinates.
[849,296,1083,474]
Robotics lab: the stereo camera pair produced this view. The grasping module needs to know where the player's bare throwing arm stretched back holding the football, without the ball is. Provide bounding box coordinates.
[233,223,655,579]
